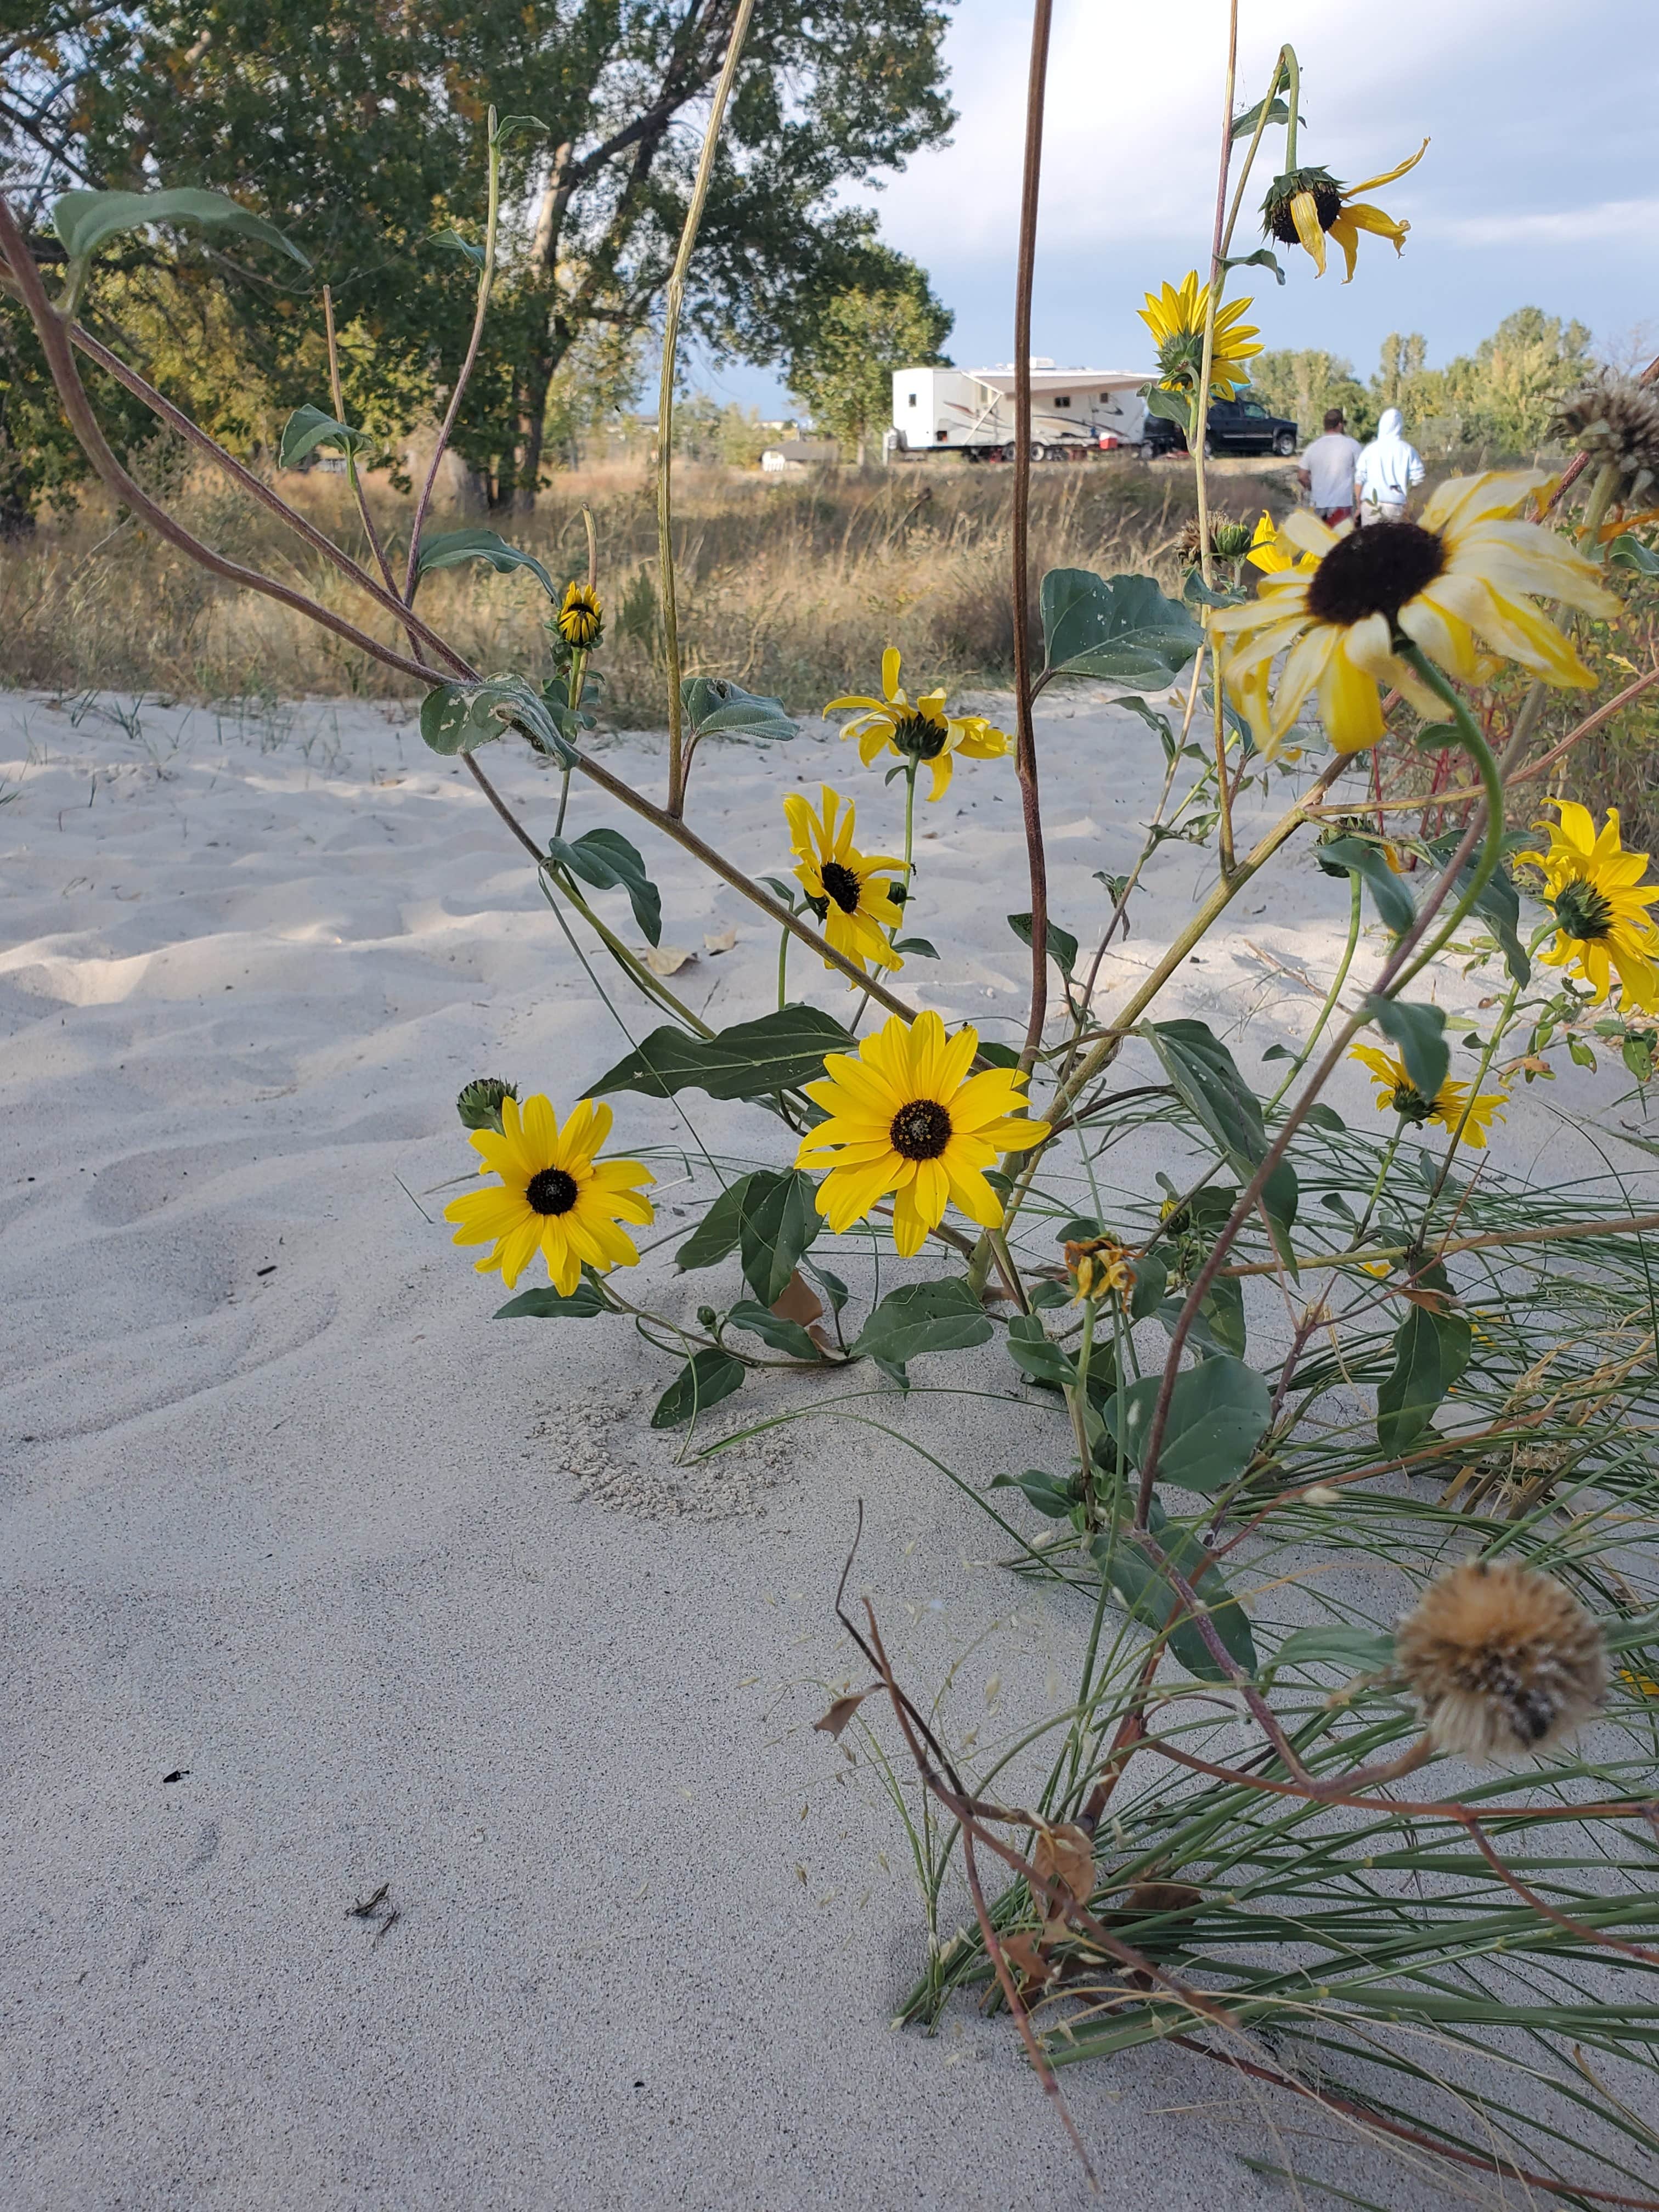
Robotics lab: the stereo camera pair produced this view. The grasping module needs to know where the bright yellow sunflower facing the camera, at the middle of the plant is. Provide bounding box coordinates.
[794,1013,1048,1259]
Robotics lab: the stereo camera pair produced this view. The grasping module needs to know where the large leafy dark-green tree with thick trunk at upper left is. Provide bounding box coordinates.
[0,0,953,498]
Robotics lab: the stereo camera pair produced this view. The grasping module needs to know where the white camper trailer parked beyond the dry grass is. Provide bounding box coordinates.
[889,360,1153,460]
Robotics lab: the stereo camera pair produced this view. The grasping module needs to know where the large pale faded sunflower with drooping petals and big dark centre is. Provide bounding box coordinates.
[1210,469,1619,754]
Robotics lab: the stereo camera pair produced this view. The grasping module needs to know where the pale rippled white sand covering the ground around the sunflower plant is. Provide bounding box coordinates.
[0,695,1606,2212]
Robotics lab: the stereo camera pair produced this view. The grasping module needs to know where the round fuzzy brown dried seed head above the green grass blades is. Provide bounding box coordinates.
[1393,1560,1608,1760]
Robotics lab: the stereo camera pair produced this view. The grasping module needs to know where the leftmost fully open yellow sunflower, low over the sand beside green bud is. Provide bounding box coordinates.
[444,1095,654,1299]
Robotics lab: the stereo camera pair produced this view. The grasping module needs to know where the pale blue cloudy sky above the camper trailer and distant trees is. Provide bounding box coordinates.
[695,0,1659,414]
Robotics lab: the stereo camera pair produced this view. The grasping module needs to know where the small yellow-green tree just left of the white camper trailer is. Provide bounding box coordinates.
[789,246,956,469]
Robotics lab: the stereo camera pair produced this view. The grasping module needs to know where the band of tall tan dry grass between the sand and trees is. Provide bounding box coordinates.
[0,449,1238,728]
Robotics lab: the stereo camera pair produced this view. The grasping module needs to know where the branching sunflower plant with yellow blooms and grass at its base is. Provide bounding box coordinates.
[0,39,1659,2203]
